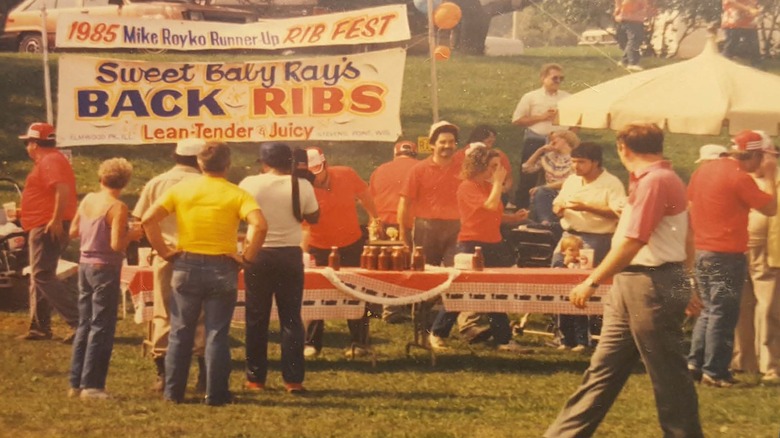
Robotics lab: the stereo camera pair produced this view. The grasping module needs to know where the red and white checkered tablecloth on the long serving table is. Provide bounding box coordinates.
[122,266,607,322]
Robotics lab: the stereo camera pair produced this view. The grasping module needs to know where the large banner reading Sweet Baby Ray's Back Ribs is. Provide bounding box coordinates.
[57,49,406,146]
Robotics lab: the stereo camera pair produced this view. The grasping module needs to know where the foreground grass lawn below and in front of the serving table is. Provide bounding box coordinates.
[0,288,780,437]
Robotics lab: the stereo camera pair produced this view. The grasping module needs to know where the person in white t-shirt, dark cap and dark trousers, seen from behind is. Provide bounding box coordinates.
[239,143,319,393]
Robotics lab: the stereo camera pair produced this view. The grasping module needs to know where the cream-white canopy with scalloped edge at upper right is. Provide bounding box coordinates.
[558,41,780,135]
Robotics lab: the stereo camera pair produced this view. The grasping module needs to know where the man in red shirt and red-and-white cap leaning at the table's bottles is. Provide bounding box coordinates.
[303,147,377,357]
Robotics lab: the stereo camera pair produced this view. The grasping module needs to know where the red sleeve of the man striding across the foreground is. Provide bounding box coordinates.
[625,177,668,243]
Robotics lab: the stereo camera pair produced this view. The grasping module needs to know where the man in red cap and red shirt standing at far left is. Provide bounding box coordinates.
[19,123,79,342]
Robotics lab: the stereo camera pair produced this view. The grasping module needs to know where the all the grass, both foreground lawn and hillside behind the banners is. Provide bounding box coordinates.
[0,48,780,437]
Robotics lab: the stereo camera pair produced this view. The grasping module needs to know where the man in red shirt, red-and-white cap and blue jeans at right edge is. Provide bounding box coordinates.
[688,130,777,387]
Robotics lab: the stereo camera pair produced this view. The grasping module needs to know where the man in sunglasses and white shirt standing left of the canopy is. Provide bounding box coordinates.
[512,64,569,208]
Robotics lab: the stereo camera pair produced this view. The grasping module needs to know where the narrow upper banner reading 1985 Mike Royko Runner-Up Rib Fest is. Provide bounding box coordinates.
[56,4,410,50]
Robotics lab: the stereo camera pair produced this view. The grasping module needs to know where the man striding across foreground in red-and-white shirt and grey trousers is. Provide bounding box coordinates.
[544,124,703,438]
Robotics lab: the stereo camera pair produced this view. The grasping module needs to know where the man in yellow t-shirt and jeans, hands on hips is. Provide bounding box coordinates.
[143,143,268,406]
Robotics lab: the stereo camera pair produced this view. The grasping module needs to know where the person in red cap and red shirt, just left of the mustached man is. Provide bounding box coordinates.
[368,140,417,324]
